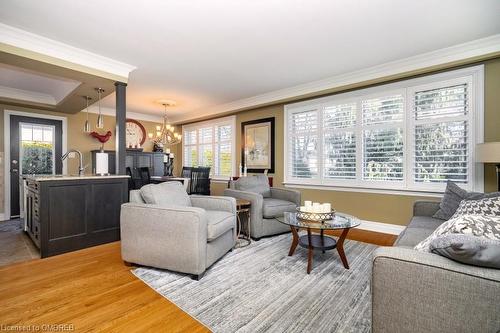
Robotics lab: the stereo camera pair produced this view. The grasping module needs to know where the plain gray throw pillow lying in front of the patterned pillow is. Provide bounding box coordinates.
[430,234,500,269]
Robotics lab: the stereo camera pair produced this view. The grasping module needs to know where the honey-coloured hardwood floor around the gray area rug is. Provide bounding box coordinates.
[0,229,396,332]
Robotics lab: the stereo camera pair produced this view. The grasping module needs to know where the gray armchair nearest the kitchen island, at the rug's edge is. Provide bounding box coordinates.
[120,182,236,280]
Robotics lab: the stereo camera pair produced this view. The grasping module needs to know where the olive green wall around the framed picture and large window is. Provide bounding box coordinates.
[193,58,500,225]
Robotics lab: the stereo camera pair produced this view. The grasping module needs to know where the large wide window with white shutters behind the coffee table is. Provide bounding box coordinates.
[284,66,483,192]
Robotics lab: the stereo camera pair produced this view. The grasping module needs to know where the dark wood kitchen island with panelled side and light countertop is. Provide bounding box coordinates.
[24,175,128,258]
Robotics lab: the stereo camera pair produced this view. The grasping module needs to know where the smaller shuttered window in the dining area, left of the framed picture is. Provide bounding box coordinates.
[182,116,236,179]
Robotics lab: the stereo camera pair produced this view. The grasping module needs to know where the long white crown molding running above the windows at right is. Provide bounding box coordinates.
[173,34,500,123]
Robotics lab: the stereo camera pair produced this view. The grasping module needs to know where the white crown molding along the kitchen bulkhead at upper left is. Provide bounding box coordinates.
[0,23,137,79]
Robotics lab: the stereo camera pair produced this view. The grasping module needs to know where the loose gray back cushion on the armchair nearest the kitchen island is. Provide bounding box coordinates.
[141,182,191,207]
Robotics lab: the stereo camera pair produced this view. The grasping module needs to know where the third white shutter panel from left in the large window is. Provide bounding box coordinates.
[361,94,404,182]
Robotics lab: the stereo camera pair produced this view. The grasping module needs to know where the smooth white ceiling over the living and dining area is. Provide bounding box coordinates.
[0,0,500,121]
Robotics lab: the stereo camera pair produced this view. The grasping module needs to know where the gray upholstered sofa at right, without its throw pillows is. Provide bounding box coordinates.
[371,201,500,333]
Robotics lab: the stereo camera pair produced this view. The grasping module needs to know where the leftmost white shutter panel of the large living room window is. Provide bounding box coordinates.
[287,108,319,178]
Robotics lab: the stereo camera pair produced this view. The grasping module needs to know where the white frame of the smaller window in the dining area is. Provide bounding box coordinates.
[181,116,236,181]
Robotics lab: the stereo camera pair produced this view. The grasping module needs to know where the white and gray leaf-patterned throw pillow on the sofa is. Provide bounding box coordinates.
[415,215,500,252]
